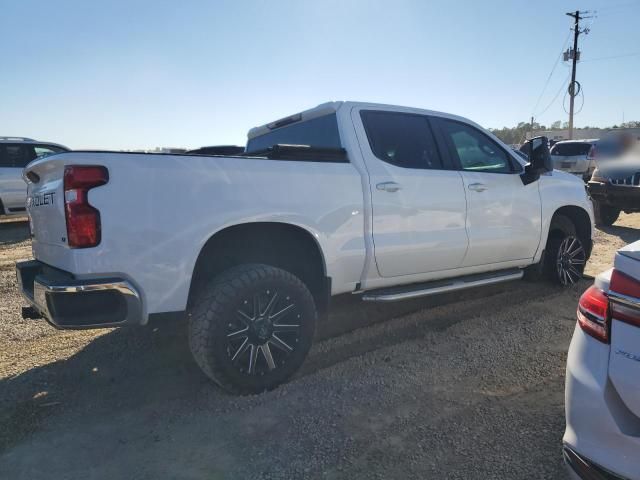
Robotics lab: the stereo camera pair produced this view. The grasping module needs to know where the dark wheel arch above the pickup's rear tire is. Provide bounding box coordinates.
[188,221,331,316]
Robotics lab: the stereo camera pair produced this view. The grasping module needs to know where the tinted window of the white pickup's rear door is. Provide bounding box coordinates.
[360,110,443,170]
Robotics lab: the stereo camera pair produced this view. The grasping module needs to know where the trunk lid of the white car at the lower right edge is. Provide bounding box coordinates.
[609,242,640,417]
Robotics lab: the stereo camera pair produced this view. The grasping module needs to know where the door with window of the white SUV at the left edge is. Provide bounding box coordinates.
[0,143,35,213]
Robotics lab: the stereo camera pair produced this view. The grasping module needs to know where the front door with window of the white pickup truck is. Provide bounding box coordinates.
[434,118,542,267]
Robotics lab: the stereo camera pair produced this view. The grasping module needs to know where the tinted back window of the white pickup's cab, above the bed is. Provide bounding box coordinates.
[247,113,342,153]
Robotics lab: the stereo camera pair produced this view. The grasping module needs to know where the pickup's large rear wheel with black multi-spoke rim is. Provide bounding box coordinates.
[188,264,317,394]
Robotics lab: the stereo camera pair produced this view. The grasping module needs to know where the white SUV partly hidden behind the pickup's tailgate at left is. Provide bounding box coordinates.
[0,137,69,216]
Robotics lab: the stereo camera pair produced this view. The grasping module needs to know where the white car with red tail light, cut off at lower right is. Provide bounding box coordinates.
[563,241,640,480]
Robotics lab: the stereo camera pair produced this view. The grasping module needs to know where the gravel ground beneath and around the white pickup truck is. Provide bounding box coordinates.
[0,215,640,479]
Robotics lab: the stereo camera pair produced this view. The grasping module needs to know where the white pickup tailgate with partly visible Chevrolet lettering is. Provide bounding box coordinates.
[24,154,67,246]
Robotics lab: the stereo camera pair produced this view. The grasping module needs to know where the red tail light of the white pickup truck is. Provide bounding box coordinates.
[64,165,109,248]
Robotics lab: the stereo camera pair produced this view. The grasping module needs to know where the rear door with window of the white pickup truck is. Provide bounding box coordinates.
[352,108,467,277]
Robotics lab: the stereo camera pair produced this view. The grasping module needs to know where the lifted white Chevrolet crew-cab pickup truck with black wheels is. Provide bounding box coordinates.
[17,102,593,393]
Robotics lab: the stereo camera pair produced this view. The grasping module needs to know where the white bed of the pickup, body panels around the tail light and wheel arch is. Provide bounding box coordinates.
[25,151,365,319]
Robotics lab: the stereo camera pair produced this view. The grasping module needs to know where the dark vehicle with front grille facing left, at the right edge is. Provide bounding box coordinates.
[587,151,640,226]
